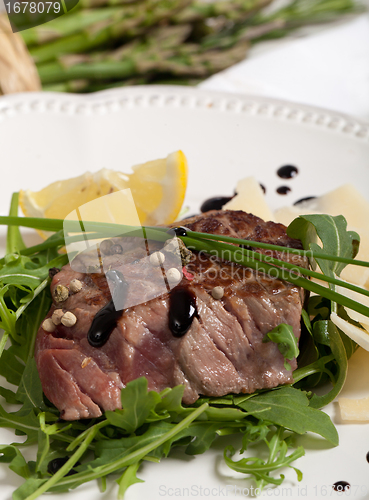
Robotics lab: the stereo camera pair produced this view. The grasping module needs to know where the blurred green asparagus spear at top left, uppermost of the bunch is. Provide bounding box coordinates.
[30,0,191,63]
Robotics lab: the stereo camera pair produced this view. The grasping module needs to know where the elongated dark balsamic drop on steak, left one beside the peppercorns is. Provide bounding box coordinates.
[87,270,128,347]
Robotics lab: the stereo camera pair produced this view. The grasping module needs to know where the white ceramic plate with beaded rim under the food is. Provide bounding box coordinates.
[0,86,369,500]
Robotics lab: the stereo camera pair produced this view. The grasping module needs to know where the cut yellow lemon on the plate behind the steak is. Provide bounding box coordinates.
[19,151,188,232]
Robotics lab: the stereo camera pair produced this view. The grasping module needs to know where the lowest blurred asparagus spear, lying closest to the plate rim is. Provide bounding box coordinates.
[39,25,248,85]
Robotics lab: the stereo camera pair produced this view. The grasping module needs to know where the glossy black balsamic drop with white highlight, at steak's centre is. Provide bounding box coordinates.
[169,288,198,337]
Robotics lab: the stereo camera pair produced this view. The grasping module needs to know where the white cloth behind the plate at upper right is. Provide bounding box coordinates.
[200,14,369,120]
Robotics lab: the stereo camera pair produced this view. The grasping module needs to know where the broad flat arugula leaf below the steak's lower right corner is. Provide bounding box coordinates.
[238,387,338,446]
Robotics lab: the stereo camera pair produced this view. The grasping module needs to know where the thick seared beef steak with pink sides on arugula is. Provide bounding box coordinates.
[36,211,307,420]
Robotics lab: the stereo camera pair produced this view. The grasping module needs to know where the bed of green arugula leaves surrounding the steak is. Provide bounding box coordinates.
[0,194,369,500]
